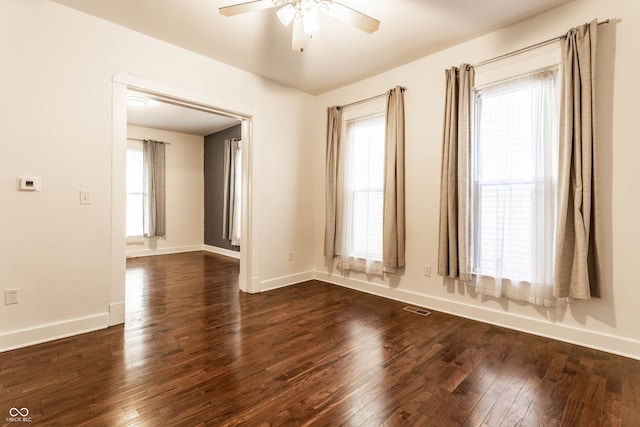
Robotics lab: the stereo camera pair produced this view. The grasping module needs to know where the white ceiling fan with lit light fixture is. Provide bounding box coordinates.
[218,0,380,52]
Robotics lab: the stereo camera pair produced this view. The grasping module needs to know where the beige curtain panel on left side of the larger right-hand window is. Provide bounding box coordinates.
[438,64,474,280]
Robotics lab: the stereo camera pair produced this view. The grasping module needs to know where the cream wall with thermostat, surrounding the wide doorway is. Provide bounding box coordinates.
[0,0,313,351]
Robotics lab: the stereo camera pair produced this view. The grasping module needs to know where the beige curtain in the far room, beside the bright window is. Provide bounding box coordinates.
[142,139,166,237]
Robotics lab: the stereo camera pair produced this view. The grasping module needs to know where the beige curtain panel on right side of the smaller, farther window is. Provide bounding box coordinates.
[382,86,405,272]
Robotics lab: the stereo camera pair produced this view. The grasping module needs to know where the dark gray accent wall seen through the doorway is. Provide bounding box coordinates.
[204,125,242,252]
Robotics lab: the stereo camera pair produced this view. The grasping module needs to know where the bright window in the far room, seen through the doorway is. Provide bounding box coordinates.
[127,141,144,237]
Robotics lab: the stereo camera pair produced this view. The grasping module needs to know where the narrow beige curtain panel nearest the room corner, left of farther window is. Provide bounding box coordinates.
[324,106,342,258]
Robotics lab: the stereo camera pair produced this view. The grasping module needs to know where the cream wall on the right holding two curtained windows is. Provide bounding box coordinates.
[313,0,640,358]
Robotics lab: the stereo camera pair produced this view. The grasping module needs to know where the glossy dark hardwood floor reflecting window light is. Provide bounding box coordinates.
[0,252,640,427]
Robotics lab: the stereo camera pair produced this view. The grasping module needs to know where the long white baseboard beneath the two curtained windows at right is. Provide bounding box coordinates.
[314,270,640,360]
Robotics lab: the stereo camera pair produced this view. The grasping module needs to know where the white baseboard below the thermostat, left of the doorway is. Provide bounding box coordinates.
[0,313,109,353]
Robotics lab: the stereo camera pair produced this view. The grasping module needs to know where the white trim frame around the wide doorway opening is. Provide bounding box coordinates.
[109,73,258,326]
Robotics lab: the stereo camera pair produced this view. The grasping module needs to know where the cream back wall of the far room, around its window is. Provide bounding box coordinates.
[126,125,204,256]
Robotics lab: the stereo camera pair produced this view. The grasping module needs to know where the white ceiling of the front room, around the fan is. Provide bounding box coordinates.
[52,0,571,94]
